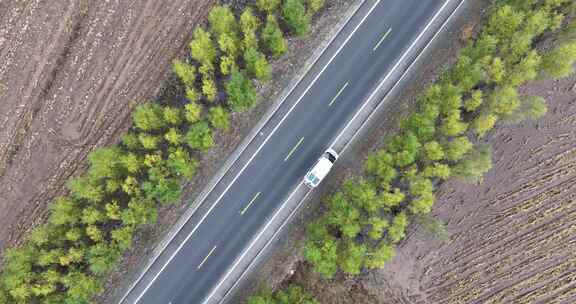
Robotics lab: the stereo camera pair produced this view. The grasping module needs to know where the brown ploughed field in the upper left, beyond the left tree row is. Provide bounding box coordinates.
[0,0,214,252]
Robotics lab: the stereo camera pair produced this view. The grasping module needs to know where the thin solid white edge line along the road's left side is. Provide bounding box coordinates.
[126,0,382,304]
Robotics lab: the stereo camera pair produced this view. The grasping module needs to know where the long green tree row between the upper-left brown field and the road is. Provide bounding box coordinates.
[0,0,324,304]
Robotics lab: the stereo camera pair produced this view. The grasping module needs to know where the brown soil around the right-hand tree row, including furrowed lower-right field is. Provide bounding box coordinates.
[245,2,576,304]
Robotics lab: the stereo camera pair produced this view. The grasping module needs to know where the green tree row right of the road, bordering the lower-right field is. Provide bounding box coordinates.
[304,0,576,279]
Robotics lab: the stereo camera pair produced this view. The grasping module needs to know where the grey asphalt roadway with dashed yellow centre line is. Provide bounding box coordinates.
[124,0,456,304]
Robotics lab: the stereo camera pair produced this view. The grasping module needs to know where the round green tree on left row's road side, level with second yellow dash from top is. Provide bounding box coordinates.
[224,71,256,112]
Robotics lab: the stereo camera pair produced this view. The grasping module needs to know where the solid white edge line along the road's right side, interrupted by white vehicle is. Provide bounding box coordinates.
[209,0,466,304]
